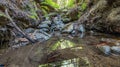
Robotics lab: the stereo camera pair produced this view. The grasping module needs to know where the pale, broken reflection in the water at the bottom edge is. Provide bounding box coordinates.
[39,57,90,67]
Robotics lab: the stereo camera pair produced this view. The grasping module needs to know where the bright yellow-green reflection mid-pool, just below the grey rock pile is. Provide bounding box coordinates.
[50,39,75,50]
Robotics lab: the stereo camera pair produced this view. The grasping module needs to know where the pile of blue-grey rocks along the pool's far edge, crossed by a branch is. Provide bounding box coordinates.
[10,15,85,48]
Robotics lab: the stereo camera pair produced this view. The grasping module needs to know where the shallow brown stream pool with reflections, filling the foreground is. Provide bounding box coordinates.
[0,32,120,67]
